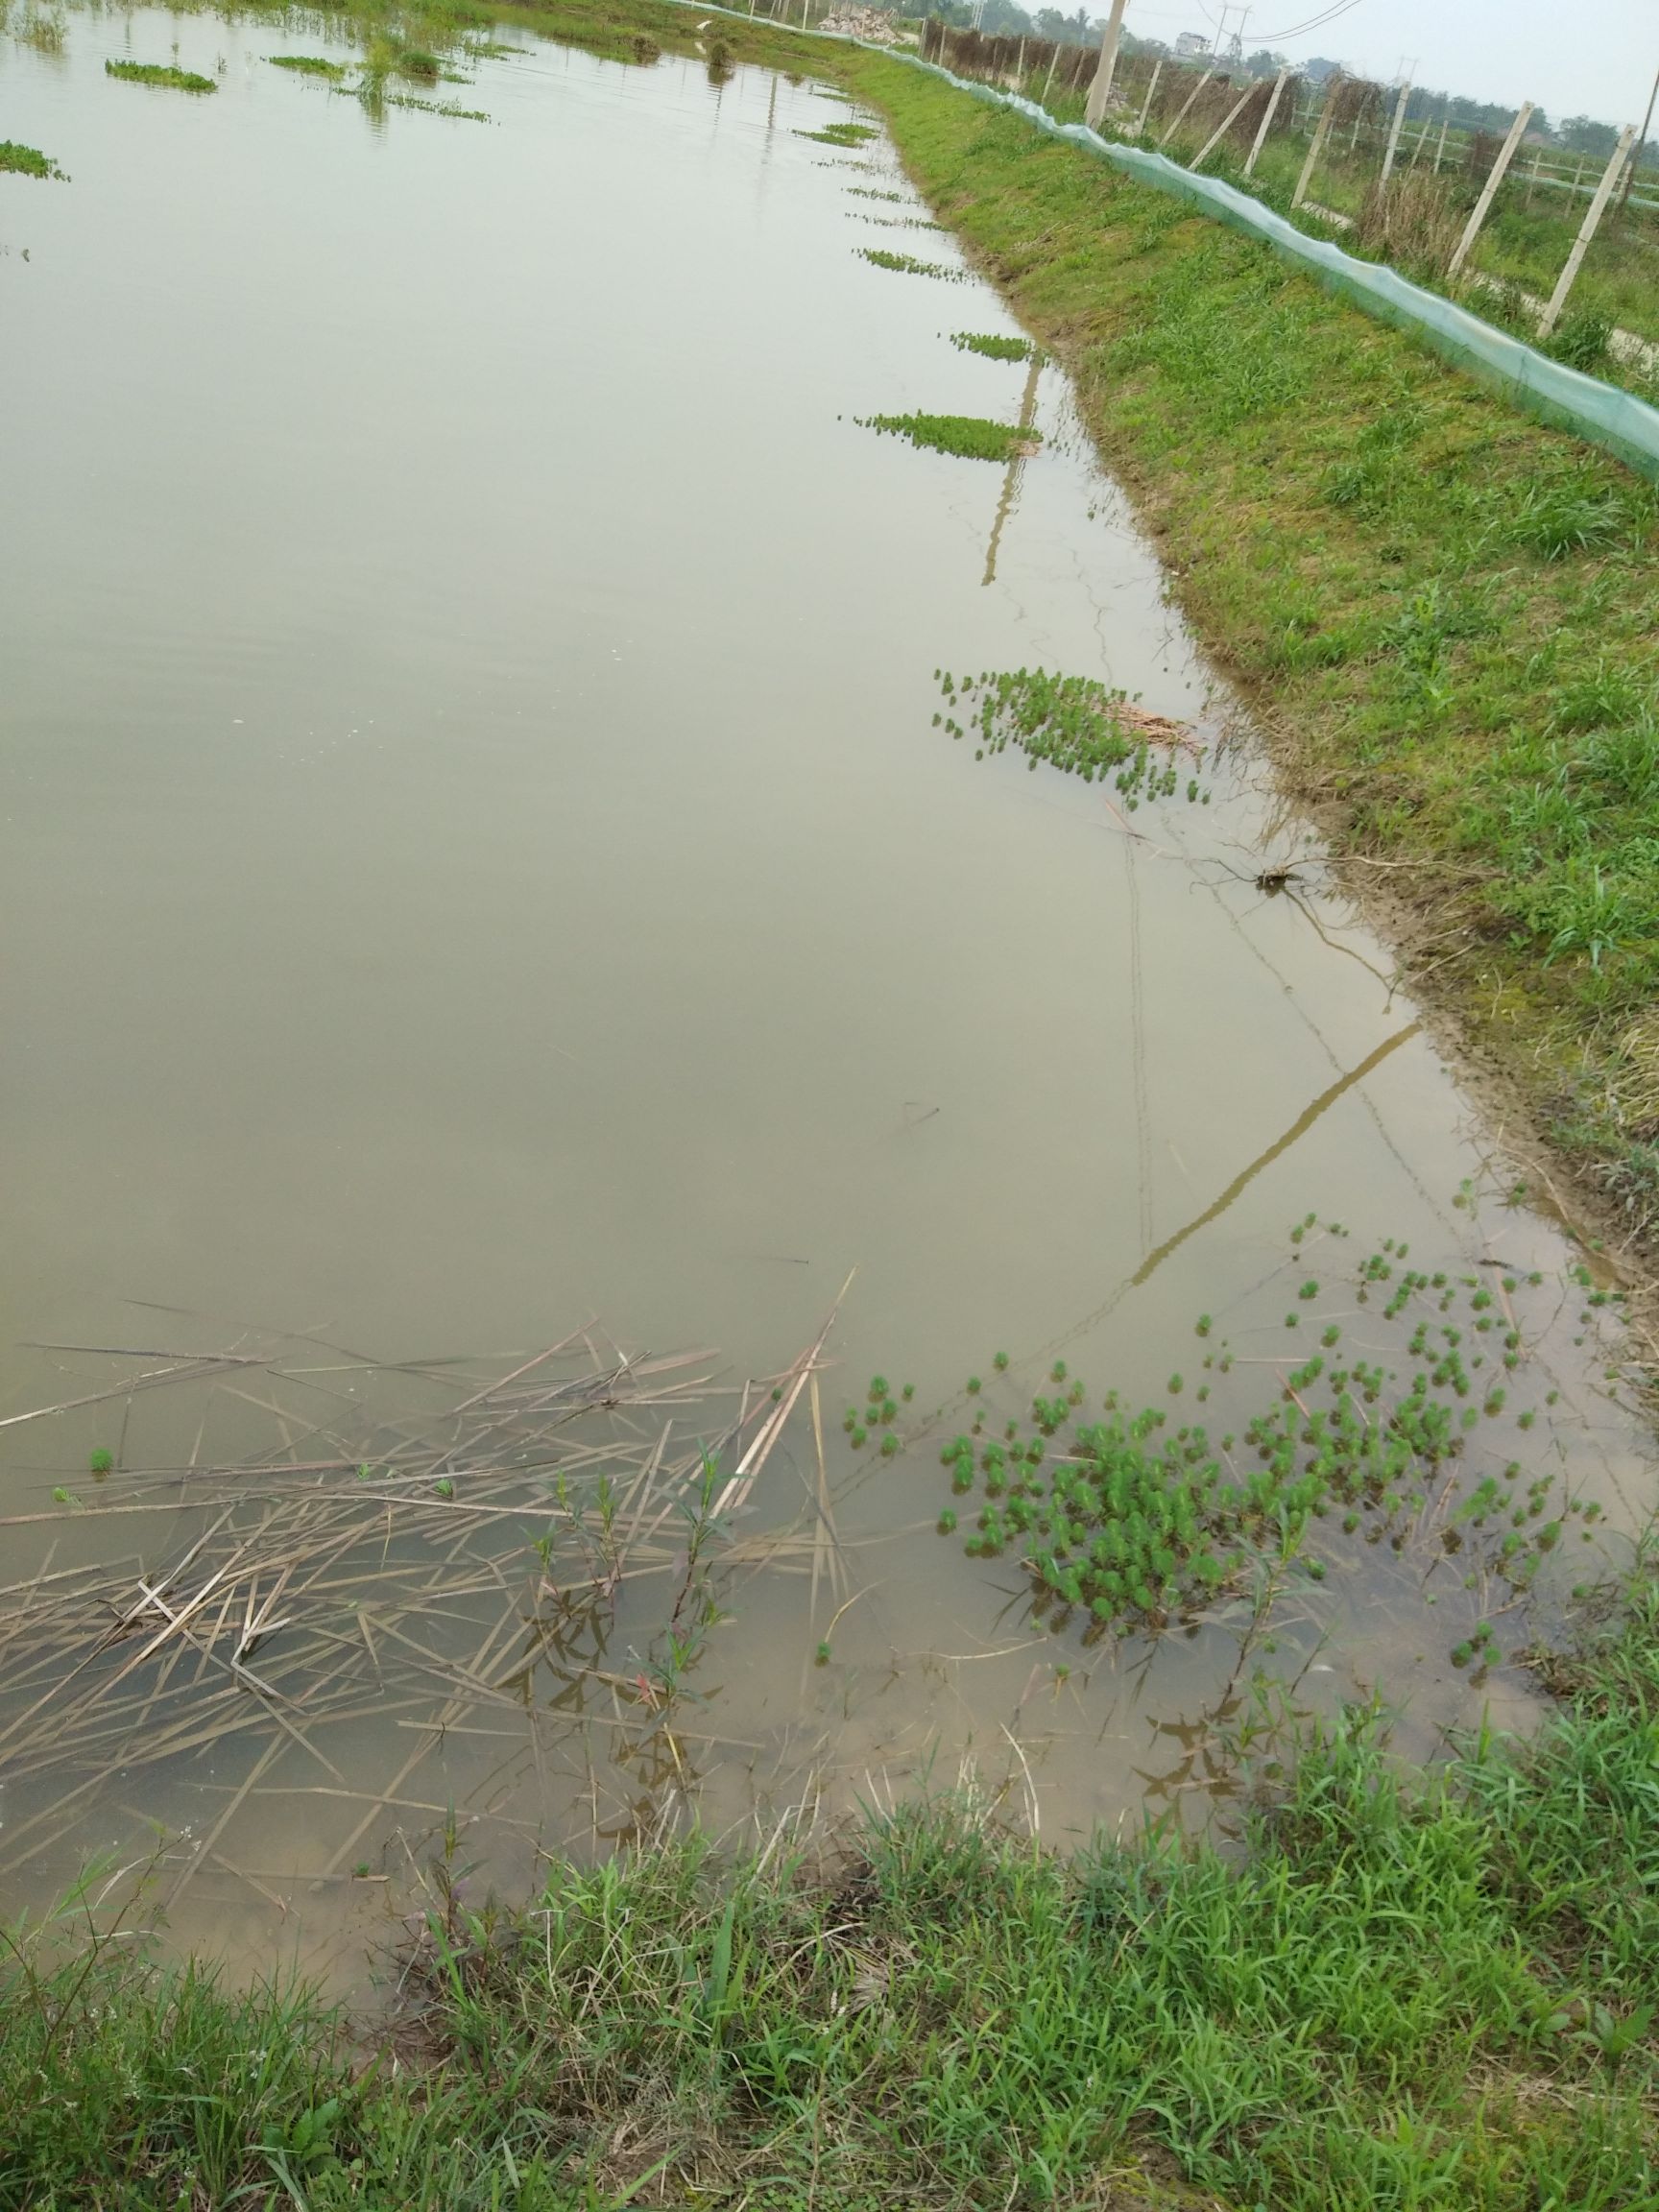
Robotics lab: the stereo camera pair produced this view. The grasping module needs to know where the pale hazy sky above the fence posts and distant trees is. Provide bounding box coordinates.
[1132,0,1659,124]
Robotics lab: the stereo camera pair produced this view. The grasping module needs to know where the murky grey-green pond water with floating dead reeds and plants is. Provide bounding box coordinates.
[0,9,1650,1958]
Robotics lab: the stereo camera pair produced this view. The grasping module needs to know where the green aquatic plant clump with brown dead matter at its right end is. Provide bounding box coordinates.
[933,668,1210,809]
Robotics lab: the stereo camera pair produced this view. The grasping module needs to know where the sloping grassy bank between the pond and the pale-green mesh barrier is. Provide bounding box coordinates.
[353,0,1659,1276]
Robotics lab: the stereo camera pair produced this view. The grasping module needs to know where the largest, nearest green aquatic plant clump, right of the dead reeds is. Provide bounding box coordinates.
[940,1223,1595,1664]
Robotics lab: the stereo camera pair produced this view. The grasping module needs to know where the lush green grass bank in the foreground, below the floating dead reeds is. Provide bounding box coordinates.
[0,1581,1659,2212]
